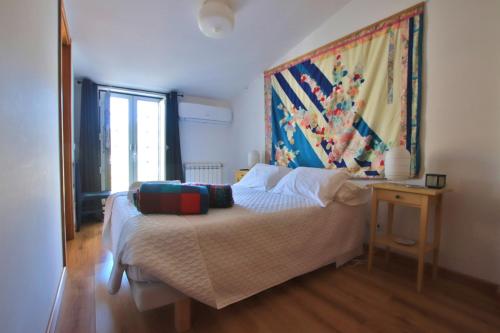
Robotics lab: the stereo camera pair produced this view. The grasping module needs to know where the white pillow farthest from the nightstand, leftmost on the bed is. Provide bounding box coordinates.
[237,163,291,191]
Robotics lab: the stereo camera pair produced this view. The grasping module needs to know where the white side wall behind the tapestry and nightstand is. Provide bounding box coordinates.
[232,0,500,284]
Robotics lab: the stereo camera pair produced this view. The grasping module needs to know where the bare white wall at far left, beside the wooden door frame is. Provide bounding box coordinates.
[0,0,62,333]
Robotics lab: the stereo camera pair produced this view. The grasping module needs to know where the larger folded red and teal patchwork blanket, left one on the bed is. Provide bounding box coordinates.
[136,182,209,215]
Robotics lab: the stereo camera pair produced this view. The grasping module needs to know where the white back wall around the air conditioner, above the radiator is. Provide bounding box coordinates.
[179,96,234,183]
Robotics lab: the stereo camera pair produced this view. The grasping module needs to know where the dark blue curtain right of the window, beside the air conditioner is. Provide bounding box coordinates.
[165,91,184,181]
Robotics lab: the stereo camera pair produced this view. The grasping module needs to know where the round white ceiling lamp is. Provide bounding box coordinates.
[198,0,234,38]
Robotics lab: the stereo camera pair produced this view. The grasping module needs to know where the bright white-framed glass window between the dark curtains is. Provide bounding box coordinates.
[99,90,166,192]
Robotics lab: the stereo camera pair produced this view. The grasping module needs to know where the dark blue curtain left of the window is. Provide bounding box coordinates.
[78,79,101,192]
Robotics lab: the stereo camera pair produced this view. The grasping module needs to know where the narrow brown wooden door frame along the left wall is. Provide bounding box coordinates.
[59,0,75,264]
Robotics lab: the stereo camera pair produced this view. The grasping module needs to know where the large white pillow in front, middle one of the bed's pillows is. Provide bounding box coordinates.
[271,167,349,207]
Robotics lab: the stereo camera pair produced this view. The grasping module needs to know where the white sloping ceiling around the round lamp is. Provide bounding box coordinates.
[65,0,349,99]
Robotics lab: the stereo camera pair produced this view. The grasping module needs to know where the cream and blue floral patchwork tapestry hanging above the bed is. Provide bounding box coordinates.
[264,4,424,178]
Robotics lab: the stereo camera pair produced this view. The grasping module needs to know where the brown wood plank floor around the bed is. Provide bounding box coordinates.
[57,223,500,333]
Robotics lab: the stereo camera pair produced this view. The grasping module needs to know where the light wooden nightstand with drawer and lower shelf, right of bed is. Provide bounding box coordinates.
[368,183,451,292]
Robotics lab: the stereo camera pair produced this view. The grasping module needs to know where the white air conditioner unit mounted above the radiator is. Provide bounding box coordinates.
[179,102,233,125]
